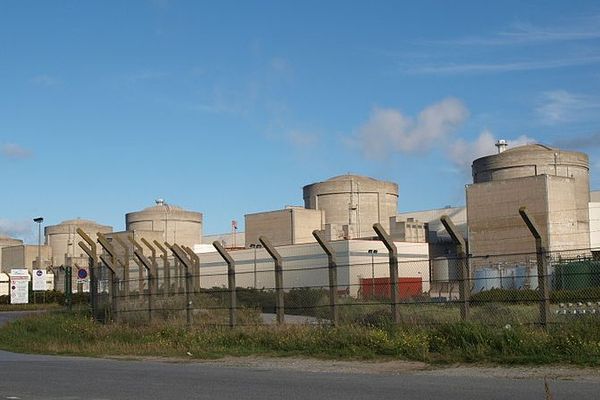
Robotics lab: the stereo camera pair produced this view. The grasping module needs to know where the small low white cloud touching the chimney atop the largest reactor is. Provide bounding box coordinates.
[448,129,535,171]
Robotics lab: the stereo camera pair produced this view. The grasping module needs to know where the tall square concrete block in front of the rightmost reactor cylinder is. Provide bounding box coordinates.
[467,175,589,256]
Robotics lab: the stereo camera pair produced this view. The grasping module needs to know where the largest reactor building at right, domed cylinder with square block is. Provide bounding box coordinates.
[467,142,590,257]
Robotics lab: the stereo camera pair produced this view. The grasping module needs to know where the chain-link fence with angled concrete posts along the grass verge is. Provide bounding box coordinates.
[69,241,600,326]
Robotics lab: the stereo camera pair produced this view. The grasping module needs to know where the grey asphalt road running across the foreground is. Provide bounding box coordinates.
[0,313,600,400]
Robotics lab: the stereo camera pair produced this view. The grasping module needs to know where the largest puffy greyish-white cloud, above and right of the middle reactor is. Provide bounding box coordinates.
[352,98,469,158]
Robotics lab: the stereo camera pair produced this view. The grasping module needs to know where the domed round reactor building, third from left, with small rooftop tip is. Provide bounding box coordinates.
[125,199,202,248]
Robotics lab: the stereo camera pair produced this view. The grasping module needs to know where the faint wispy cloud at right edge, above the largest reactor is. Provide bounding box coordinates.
[535,90,600,125]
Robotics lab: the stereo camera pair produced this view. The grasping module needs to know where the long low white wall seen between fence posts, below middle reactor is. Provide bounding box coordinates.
[198,240,429,296]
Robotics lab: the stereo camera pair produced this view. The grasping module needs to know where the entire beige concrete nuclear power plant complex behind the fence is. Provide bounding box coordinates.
[0,141,600,295]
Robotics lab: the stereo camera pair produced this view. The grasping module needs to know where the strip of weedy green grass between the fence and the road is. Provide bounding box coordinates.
[0,313,600,366]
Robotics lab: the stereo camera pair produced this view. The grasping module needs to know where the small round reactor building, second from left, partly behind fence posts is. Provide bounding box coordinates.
[44,219,113,266]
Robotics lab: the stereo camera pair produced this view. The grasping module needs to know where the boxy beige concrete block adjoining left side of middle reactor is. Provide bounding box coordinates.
[245,207,324,247]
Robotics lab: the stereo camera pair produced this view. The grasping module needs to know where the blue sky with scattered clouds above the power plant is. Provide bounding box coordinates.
[0,0,600,241]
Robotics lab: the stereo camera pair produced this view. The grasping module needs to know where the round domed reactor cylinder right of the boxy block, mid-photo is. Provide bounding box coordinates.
[303,174,398,239]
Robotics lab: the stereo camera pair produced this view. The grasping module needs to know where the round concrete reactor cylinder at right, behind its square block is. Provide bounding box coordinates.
[472,144,590,247]
